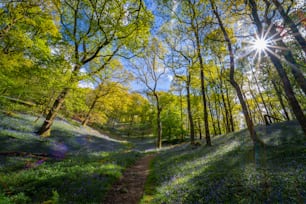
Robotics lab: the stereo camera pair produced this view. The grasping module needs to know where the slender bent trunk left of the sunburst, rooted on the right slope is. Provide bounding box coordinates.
[210,0,262,145]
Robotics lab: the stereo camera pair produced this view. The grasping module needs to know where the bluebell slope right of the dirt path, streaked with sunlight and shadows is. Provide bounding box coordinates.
[142,122,306,203]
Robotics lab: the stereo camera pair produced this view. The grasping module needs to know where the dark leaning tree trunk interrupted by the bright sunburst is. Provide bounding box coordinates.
[249,0,306,136]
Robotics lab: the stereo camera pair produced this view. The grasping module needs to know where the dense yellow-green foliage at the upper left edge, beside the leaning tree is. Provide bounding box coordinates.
[0,0,61,103]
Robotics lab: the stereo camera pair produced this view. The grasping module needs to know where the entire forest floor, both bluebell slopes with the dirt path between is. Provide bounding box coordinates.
[0,112,306,204]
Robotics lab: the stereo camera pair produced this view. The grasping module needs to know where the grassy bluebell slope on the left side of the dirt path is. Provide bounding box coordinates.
[0,113,141,204]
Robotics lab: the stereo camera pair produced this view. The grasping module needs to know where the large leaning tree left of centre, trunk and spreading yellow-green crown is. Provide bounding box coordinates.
[38,0,151,136]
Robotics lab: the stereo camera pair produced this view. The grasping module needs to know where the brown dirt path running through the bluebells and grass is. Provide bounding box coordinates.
[103,154,154,204]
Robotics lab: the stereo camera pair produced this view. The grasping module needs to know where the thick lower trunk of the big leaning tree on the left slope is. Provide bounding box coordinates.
[37,88,70,137]
